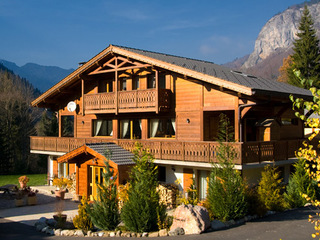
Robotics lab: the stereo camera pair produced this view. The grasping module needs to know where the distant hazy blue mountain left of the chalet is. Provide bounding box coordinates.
[0,59,74,92]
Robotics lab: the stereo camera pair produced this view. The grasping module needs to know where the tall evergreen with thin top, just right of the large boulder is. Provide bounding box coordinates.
[207,114,248,221]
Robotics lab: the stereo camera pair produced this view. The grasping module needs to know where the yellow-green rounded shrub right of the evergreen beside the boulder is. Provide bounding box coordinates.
[257,165,285,211]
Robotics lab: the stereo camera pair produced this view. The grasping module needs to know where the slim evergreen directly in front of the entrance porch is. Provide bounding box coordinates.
[87,161,120,230]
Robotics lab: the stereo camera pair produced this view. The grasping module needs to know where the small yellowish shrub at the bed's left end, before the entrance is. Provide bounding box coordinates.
[73,196,93,231]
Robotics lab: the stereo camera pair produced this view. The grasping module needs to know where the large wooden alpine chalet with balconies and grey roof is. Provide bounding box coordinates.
[30,45,311,199]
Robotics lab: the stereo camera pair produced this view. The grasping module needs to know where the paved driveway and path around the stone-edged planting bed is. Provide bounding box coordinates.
[0,198,314,240]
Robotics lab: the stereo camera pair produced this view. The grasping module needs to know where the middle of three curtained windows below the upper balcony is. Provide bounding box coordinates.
[120,119,141,139]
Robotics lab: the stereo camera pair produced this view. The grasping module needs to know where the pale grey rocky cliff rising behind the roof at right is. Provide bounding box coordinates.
[235,0,320,79]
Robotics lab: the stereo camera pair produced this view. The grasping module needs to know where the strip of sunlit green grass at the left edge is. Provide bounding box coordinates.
[0,174,47,187]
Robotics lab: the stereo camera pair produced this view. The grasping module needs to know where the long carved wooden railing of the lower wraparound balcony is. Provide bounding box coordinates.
[30,137,303,164]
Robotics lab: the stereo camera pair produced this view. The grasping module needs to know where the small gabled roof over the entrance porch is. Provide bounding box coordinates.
[57,142,135,167]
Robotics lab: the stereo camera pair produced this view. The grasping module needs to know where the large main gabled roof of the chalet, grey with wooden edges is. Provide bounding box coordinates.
[31,45,312,106]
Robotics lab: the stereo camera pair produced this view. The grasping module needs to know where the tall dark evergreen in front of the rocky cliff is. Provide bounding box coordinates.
[288,5,320,89]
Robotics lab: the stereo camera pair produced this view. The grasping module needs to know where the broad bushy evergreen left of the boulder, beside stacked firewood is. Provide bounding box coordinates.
[121,144,165,232]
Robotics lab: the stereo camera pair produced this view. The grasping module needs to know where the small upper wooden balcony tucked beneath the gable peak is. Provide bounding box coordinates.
[84,89,171,114]
